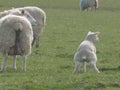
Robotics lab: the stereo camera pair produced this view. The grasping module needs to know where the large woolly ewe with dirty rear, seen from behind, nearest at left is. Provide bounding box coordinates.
[0,15,33,72]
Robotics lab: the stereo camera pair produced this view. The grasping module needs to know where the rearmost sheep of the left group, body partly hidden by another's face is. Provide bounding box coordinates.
[17,6,46,48]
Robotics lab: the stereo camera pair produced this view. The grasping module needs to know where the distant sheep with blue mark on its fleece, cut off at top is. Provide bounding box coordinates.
[80,0,98,11]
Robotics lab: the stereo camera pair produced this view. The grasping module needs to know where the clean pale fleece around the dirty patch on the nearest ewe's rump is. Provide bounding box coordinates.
[0,15,33,54]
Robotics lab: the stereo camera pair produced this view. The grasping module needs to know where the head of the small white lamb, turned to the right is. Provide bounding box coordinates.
[86,31,100,42]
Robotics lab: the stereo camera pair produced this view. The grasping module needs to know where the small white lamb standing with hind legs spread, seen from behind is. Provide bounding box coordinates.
[73,31,99,74]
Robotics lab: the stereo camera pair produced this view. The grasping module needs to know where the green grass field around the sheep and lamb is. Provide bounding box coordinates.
[0,0,120,90]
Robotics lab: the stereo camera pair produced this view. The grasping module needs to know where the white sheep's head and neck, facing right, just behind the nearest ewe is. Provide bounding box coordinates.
[10,9,37,26]
